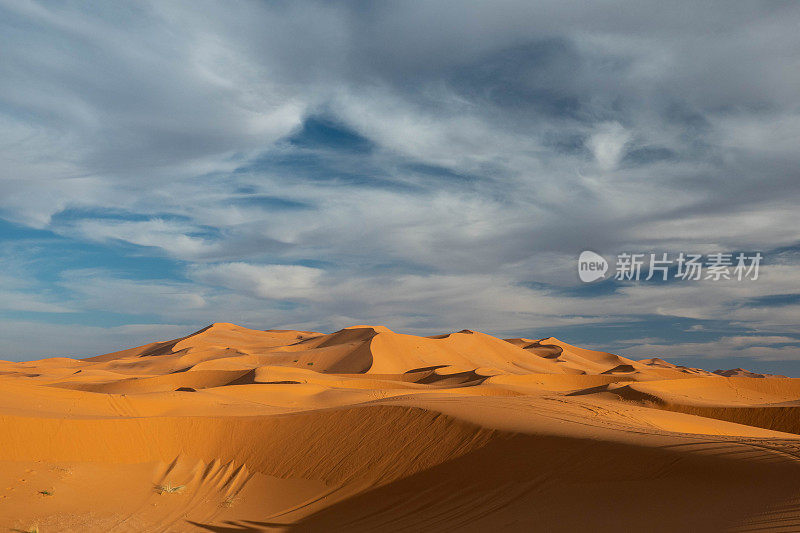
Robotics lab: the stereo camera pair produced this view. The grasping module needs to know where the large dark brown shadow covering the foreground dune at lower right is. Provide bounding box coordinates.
[241,435,790,532]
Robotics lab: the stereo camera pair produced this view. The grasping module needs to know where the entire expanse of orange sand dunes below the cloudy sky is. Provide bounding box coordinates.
[0,323,800,532]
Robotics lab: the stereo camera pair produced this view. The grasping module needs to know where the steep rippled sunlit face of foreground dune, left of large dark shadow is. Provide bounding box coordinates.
[0,406,497,484]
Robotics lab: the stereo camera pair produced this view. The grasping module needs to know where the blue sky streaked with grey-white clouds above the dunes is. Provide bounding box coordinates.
[0,0,800,376]
